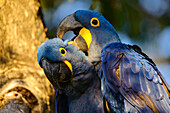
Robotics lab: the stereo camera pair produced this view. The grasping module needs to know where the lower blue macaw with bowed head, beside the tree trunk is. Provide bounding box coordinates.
[37,38,105,113]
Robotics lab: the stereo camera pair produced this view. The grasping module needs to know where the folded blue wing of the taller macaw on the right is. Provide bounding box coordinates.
[101,43,170,112]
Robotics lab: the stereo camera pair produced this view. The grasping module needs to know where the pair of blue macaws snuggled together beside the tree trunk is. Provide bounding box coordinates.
[37,10,170,113]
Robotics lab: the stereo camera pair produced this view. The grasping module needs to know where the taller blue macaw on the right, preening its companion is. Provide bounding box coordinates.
[57,10,170,113]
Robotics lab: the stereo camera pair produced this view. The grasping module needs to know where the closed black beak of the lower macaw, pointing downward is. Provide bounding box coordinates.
[42,59,72,89]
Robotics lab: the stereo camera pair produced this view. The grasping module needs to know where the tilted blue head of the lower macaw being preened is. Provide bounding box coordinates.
[37,38,94,94]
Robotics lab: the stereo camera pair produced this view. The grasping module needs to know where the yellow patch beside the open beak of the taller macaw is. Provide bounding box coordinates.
[79,27,92,48]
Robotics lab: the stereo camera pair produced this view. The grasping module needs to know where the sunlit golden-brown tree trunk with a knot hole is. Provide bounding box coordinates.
[0,0,54,113]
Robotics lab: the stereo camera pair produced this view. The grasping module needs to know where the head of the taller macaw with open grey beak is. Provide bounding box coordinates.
[57,10,120,62]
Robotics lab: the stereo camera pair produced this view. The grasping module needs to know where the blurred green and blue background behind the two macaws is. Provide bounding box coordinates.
[40,0,170,84]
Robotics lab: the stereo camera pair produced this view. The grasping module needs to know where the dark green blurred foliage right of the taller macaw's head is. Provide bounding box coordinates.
[100,0,170,39]
